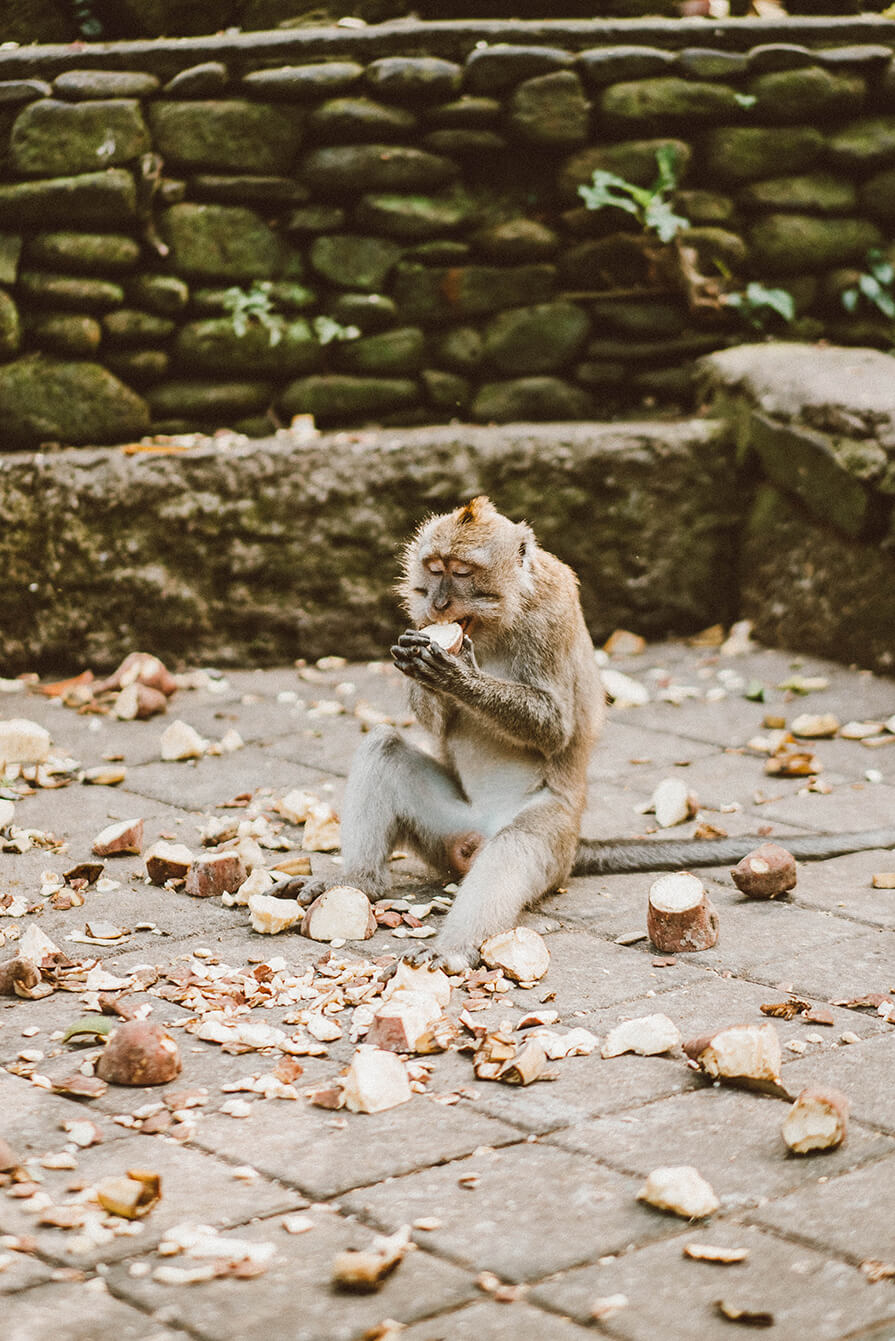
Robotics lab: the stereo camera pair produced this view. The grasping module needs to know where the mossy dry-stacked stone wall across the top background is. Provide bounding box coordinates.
[0,19,895,448]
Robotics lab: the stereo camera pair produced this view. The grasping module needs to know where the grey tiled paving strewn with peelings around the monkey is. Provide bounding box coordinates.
[0,644,895,1341]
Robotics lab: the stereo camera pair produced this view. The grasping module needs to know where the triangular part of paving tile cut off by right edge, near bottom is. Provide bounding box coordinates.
[750,1158,895,1260]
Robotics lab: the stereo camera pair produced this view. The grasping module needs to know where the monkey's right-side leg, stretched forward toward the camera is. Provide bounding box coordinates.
[432,802,576,972]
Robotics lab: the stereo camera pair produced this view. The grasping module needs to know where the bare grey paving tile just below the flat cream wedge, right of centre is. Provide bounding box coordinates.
[471,1051,692,1133]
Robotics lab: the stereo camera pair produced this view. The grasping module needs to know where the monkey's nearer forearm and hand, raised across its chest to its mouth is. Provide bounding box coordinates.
[392,630,572,756]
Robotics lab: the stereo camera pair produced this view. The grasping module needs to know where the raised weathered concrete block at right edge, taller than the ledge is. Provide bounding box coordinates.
[700,342,895,671]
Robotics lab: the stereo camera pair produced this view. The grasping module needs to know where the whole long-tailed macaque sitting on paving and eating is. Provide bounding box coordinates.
[276,498,895,970]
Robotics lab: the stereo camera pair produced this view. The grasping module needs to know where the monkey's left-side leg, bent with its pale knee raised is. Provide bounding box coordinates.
[328,727,476,896]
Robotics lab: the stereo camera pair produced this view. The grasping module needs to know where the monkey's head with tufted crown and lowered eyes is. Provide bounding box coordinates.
[399,498,537,638]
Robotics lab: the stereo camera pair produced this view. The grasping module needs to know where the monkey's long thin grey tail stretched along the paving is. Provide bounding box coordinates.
[572,829,895,876]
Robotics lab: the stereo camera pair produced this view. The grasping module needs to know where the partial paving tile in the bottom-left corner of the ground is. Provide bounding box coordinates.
[3,1279,187,1341]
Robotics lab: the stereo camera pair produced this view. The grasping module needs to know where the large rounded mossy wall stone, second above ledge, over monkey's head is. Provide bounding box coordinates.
[484,303,590,374]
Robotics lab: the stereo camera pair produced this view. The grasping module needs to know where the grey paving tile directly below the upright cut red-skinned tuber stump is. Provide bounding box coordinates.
[513,931,703,1015]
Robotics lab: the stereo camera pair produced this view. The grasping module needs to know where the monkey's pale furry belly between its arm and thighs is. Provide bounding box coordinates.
[451,728,546,835]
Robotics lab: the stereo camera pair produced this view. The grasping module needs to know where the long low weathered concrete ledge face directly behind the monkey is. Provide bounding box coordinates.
[0,420,741,675]
